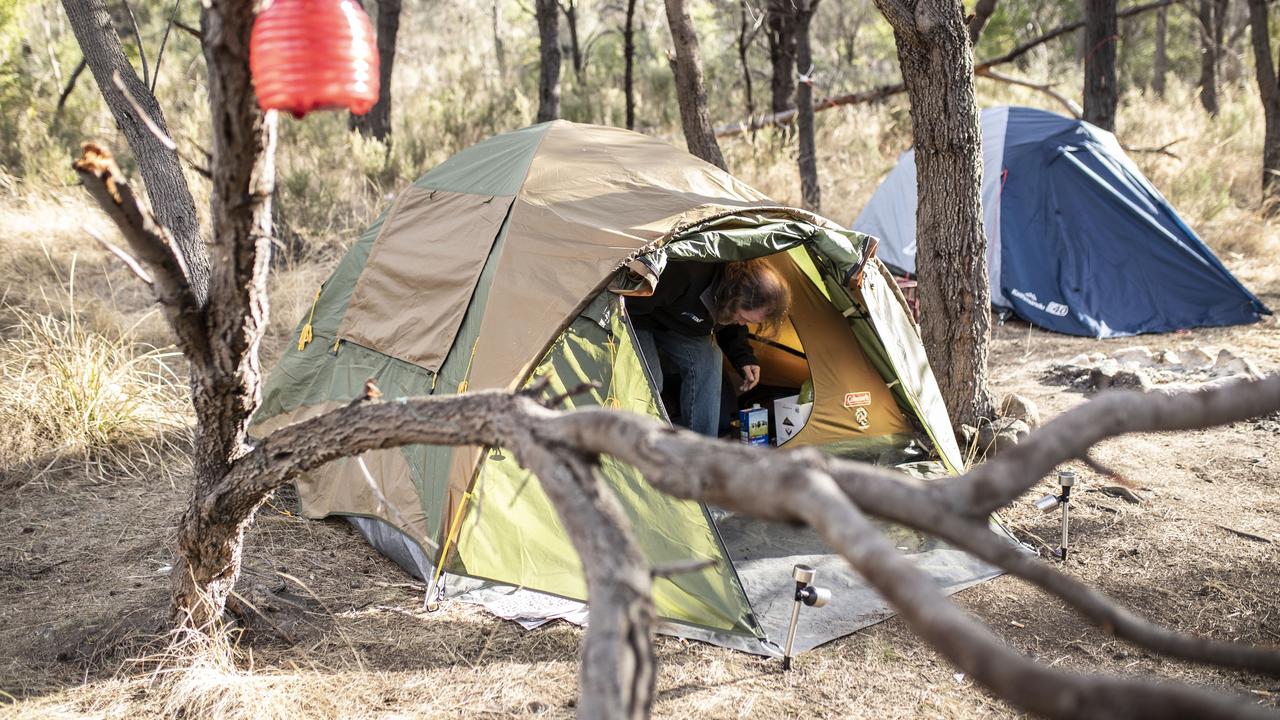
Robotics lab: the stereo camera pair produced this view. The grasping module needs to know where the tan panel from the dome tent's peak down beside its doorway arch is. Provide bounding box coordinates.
[468,122,773,389]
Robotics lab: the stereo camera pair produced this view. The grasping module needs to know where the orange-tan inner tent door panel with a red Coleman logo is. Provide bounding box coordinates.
[762,254,911,446]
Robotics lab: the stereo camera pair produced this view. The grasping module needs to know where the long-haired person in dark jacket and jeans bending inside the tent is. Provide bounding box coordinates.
[627,260,791,437]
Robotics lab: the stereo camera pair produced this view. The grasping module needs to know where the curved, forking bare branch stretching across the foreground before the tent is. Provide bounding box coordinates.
[199,368,1280,717]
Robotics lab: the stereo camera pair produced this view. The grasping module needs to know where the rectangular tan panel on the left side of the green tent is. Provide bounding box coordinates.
[338,187,519,373]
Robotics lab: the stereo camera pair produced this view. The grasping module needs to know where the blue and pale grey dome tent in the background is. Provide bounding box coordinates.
[854,106,1270,337]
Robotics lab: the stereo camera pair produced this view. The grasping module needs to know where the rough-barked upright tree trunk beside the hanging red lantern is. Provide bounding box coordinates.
[172,0,275,630]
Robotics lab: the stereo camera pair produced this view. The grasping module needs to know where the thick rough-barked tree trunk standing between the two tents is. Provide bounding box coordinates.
[876,0,995,427]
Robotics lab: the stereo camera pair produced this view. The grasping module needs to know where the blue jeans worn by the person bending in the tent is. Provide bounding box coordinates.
[636,328,722,437]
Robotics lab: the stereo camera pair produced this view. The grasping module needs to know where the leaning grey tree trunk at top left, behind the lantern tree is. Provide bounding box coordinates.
[63,0,209,299]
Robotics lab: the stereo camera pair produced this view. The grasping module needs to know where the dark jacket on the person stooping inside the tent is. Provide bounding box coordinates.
[626,261,758,372]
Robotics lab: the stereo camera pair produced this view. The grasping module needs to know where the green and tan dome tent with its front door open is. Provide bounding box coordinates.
[255,120,993,653]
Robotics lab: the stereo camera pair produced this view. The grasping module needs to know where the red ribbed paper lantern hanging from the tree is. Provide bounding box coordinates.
[248,0,379,118]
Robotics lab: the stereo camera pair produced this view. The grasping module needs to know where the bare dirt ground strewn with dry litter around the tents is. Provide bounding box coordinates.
[0,213,1280,719]
